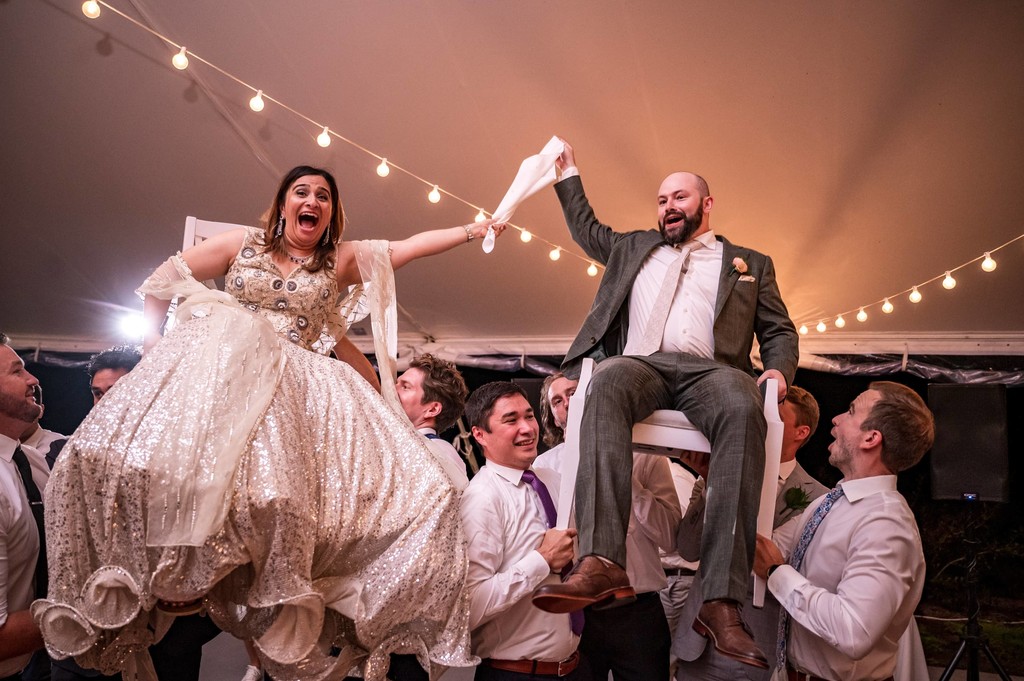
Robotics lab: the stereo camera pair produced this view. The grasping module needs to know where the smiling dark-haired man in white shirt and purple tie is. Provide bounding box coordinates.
[462,382,588,681]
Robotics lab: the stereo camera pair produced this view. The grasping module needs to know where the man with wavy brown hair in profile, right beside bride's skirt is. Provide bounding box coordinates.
[395,353,469,490]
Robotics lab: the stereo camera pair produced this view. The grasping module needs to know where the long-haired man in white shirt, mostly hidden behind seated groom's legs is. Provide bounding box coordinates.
[534,373,682,681]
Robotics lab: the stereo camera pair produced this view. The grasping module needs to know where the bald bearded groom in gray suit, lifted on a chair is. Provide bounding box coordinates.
[534,143,799,668]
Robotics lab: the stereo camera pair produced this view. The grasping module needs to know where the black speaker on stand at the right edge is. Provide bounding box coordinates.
[928,385,1010,502]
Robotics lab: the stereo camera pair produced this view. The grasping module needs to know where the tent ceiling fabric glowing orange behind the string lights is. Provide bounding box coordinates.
[0,0,1024,352]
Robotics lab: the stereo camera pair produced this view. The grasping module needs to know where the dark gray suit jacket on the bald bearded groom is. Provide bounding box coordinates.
[555,177,800,383]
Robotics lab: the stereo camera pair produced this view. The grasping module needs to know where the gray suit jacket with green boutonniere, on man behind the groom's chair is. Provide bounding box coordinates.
[672,463,828,681]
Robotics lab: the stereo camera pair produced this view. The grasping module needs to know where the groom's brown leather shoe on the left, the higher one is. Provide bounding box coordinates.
[534,554,637,612]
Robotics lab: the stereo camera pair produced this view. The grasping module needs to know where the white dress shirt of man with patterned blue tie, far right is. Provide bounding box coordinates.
[768,475,925,681]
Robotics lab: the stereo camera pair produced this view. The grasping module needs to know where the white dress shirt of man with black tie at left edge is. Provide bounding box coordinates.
[0,435,49,677]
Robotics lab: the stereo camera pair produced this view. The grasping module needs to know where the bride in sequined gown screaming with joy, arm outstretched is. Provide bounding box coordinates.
[33,167,503,681]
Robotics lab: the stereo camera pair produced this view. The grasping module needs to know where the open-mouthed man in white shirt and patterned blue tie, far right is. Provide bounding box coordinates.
[755,381,935,681]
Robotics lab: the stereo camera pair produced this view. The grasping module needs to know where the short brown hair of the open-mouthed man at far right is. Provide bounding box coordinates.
[861,381,935,473]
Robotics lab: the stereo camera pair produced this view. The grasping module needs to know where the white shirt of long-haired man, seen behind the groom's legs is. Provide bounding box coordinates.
[534,442,682,594]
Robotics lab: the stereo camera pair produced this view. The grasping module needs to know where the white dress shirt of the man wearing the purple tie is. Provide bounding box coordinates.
[462,461,580,662]
